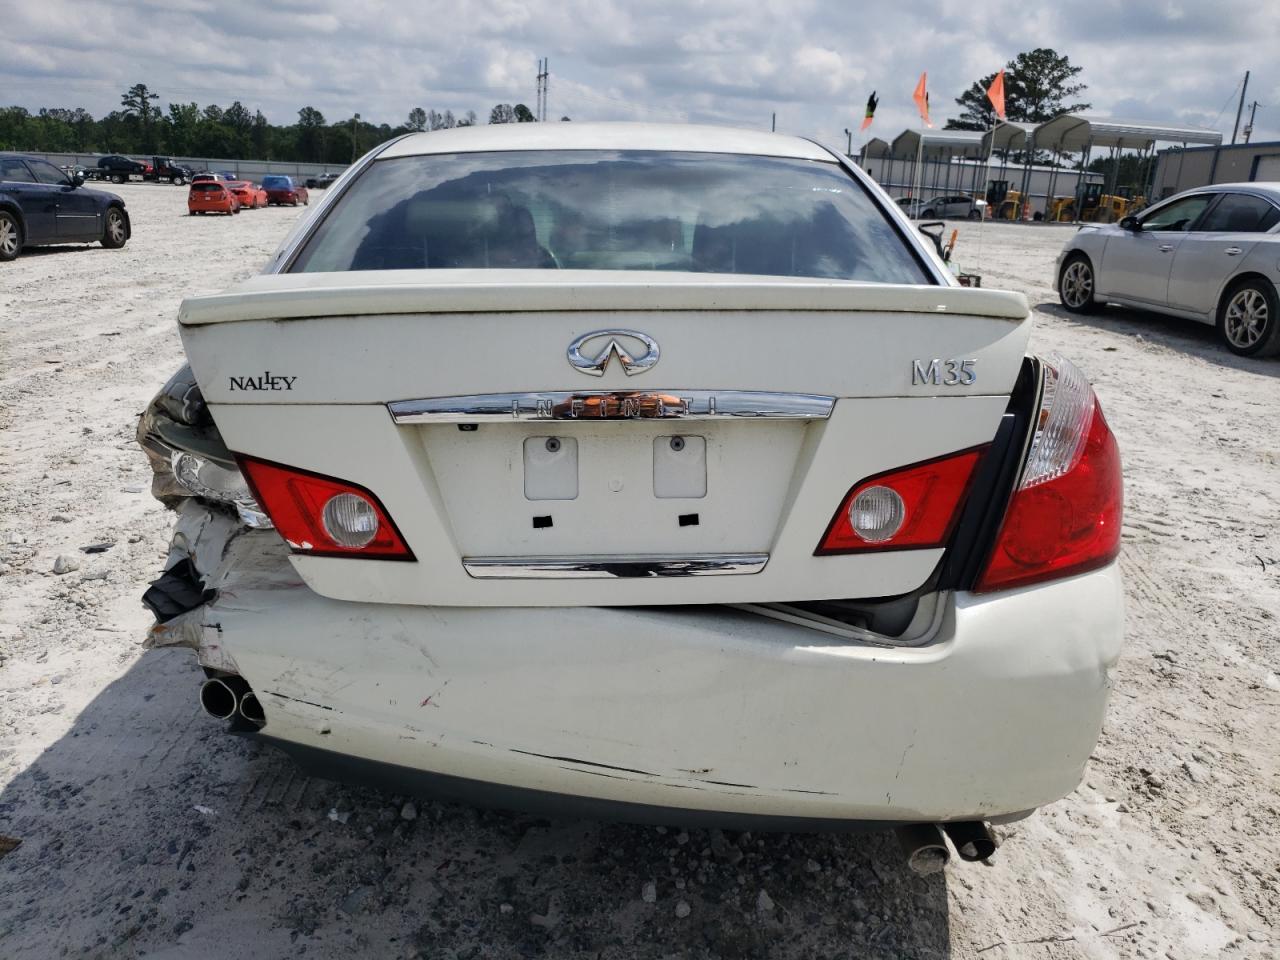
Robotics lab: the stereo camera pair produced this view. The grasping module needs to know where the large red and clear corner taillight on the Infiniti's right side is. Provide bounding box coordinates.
[975,357,1124,593]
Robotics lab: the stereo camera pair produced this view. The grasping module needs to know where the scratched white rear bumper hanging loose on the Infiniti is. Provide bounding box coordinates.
[154,514,1123,823]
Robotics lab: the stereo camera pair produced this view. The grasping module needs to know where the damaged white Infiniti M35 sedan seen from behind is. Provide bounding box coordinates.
[140,123,1123,855]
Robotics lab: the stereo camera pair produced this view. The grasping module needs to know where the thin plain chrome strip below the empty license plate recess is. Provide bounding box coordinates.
[462,553,769,580]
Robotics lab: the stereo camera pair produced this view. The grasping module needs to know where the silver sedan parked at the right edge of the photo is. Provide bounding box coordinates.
[1057,183,1280,357]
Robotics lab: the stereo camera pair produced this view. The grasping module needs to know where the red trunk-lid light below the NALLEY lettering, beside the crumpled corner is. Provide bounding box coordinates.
[237,456,413,561]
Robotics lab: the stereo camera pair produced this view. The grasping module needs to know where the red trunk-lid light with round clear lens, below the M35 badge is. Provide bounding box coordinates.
[814,447,987,557]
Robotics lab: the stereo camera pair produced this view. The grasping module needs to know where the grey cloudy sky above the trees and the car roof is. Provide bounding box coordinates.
[0,0,1280,147]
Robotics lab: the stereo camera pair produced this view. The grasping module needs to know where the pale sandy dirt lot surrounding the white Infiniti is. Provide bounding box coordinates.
[0,186,1280,960]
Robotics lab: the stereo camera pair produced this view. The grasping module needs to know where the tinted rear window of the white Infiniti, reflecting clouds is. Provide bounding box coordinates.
[291,151,929,283]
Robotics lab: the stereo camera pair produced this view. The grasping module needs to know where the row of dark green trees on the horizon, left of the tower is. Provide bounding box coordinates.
[0,83,558,165]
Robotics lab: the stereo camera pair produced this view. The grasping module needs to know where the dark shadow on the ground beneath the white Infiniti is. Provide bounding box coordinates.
[0,650,951,960]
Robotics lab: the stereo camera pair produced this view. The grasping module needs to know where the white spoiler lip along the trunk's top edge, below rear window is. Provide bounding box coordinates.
[178,270,1029,326]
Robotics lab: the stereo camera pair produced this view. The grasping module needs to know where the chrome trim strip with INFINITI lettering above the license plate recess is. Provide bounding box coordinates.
[387,390,836,424]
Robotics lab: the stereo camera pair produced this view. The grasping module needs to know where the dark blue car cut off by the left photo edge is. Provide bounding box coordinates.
[0,154,132,261]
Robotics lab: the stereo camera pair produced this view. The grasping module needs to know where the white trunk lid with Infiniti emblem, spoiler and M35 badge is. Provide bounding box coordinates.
[180,270,1029,605]
